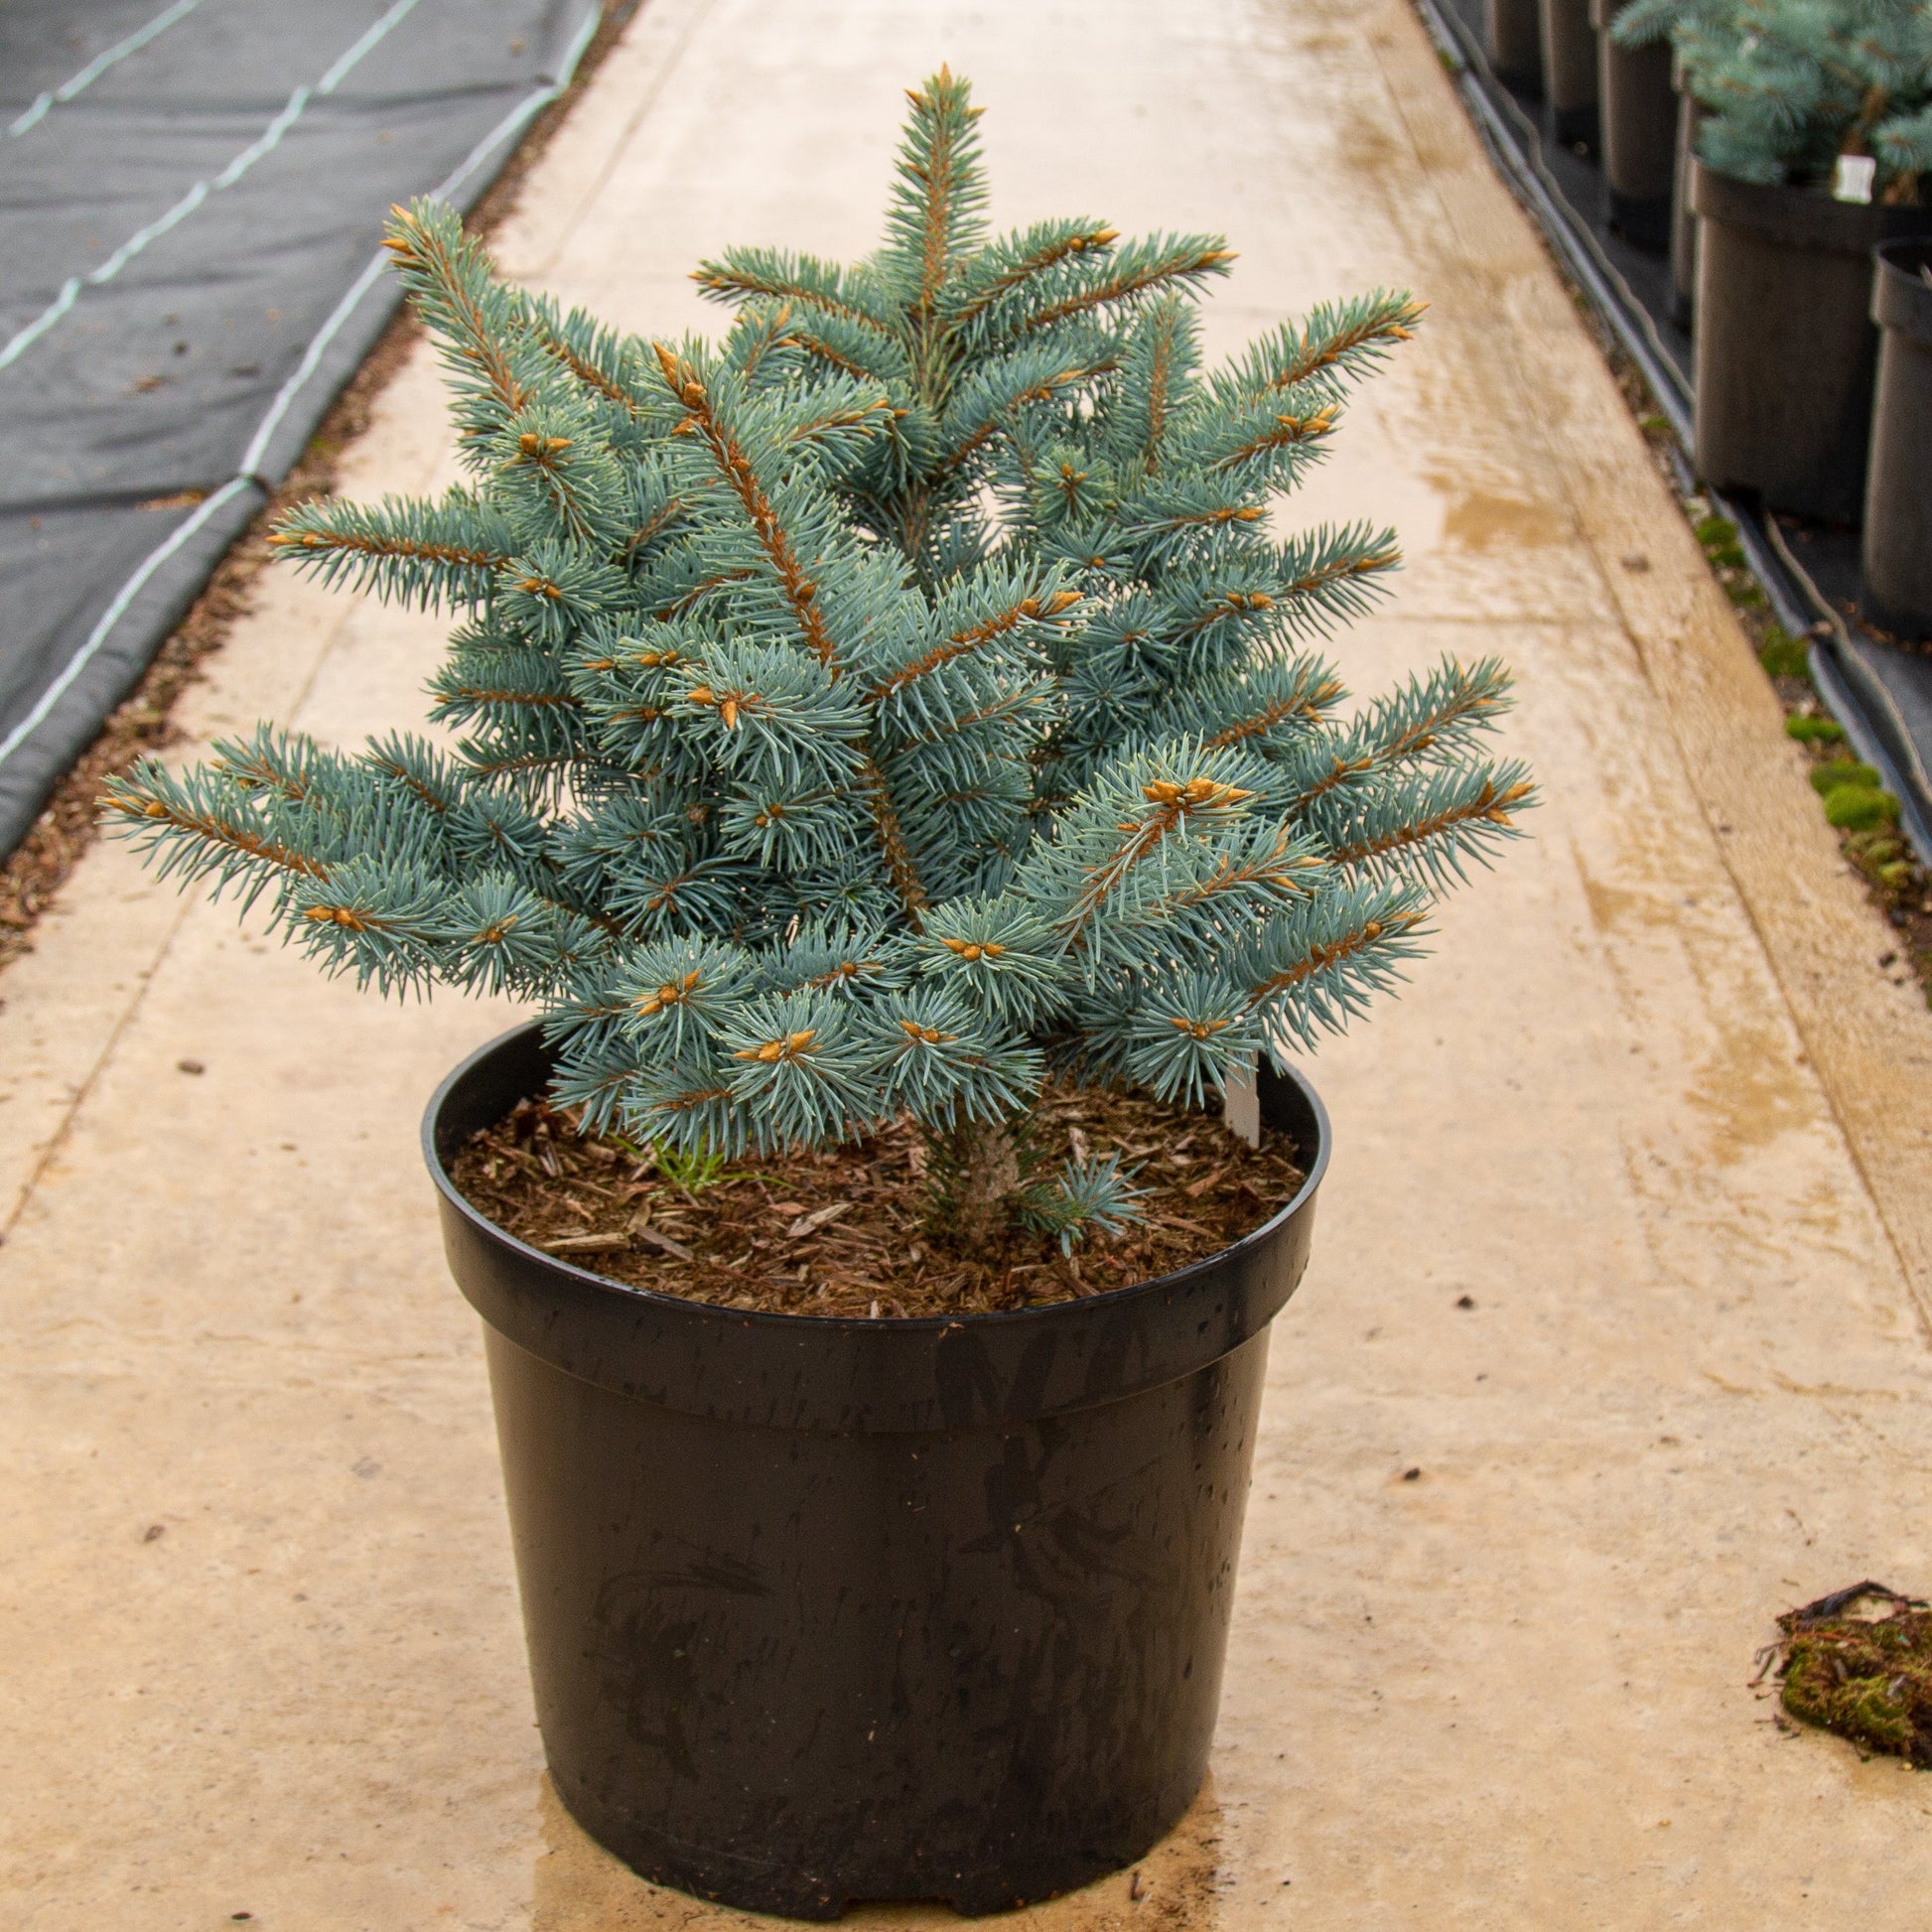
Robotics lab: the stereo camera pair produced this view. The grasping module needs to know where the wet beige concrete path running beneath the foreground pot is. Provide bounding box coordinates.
[0,0,1932,1932]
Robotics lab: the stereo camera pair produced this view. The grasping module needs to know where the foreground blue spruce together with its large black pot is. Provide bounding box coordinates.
[110,71,1530,1916]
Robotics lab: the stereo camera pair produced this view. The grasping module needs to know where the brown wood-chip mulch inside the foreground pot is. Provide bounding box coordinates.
[452,1086,1303,1319]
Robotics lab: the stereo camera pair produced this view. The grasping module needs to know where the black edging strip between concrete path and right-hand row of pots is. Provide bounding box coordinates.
[1414,0,1932,866]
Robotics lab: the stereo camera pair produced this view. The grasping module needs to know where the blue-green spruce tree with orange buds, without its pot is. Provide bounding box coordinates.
[110,73,1530,1240]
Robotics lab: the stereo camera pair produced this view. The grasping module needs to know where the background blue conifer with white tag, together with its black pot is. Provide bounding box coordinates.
[1613,0,1932,521]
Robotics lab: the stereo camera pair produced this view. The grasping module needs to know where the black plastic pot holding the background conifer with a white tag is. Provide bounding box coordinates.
[1691,161,1932,523]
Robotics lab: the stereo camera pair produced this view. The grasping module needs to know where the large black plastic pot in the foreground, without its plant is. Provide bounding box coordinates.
[423,1026,1329,1918]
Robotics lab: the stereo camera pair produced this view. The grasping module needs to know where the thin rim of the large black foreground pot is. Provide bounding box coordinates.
[419,1020,1333,1335]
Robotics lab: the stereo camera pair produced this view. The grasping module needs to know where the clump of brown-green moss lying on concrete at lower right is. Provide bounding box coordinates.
[1773,1583,1932,1770]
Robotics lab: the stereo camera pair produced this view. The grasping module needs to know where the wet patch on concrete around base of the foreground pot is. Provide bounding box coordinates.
[531,1777,1221,1932]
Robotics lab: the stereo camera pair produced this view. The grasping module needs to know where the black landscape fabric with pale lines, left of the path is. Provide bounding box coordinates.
[0,0,603,856]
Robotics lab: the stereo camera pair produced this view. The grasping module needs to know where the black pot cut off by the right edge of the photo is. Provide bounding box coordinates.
[1863,239,1932,637]
